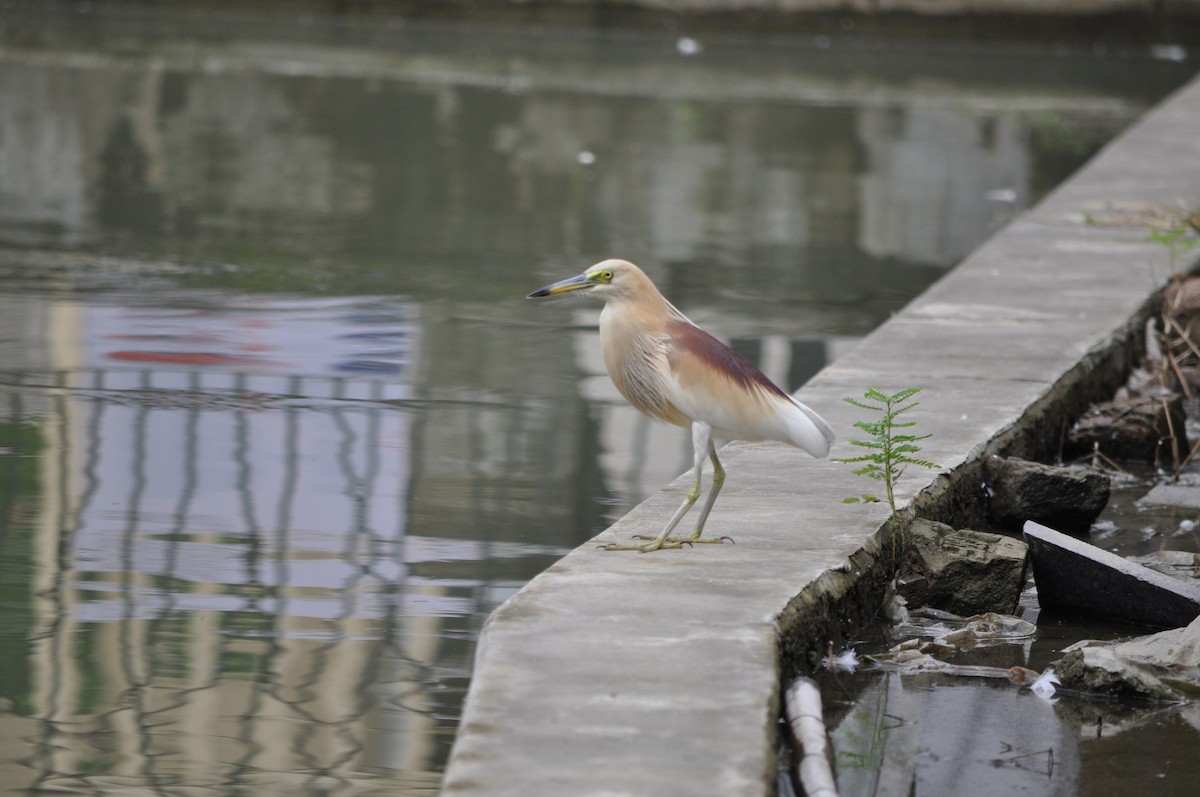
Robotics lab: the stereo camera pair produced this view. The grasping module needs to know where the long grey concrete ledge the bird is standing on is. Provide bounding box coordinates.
[444,74,1200,797]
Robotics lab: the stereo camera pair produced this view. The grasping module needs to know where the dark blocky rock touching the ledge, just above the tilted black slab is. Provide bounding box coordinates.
[984,456,1109,537]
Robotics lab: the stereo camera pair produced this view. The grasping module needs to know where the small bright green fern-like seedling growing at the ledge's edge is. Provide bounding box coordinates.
[834,388,942,528]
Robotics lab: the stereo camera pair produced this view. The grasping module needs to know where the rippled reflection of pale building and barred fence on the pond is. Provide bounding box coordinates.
[0,293,595,793]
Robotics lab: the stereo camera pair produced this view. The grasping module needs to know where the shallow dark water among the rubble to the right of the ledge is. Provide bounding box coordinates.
[806,463,1200,797]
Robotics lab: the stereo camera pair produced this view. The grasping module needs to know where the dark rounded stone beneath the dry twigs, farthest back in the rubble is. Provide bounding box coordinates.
[1063,395,1188,467]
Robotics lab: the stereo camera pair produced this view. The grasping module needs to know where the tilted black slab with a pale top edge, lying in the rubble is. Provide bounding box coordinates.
[1025,522,1200,628]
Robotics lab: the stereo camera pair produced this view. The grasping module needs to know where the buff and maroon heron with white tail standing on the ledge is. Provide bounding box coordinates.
[526,259,835,552]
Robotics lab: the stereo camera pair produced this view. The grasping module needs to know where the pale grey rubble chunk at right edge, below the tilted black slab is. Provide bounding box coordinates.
[1054,617,1200,700]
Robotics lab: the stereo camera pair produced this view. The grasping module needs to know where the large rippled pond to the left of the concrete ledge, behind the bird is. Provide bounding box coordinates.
[0,5,1189,795]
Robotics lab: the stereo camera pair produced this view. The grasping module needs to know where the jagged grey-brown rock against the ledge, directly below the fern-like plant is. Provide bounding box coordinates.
[899,520,1026,615]
